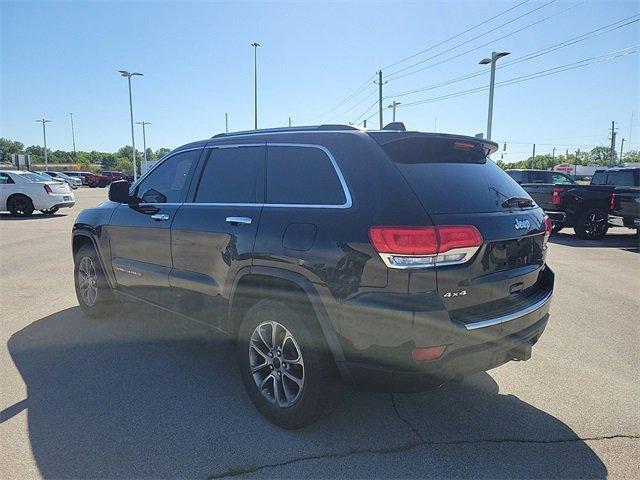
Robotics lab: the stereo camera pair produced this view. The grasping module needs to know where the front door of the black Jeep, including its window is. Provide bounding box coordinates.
[106,147,202,303]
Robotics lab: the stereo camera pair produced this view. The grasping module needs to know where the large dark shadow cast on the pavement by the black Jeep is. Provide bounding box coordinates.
[2,307,607,478]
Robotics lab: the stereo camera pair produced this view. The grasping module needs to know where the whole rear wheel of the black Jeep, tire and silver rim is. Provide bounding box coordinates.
[237,299,343,429]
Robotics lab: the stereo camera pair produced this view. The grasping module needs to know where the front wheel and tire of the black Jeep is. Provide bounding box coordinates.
[73,245,120,318]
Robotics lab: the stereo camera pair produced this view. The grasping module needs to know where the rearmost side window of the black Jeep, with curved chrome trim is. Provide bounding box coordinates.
[266,145,346,205]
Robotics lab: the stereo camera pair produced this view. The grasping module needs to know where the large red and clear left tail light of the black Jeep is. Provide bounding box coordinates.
[369,225,482,268]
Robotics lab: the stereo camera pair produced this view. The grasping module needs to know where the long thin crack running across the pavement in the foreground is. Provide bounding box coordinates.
[207,434,640,480]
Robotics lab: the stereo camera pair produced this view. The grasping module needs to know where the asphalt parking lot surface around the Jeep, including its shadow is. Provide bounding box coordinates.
[0,189,640,479]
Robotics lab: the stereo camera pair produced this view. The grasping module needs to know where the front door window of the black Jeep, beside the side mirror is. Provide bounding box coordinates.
[137,149,202,203]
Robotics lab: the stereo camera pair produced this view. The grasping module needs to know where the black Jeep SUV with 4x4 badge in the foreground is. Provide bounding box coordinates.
[73,125,554,428]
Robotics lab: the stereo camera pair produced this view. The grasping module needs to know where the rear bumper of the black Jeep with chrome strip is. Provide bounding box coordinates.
[341,267,554,391]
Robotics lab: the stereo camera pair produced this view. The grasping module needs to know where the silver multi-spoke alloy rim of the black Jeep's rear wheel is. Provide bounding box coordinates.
[249,321,305,408]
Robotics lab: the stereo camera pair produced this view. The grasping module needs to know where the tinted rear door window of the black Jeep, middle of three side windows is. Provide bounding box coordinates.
[195,147,264,203]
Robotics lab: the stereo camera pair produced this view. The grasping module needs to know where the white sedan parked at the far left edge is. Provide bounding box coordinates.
[0,170,75,217]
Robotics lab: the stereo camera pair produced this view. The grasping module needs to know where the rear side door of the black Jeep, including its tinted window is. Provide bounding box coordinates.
[169,143,265,328]
